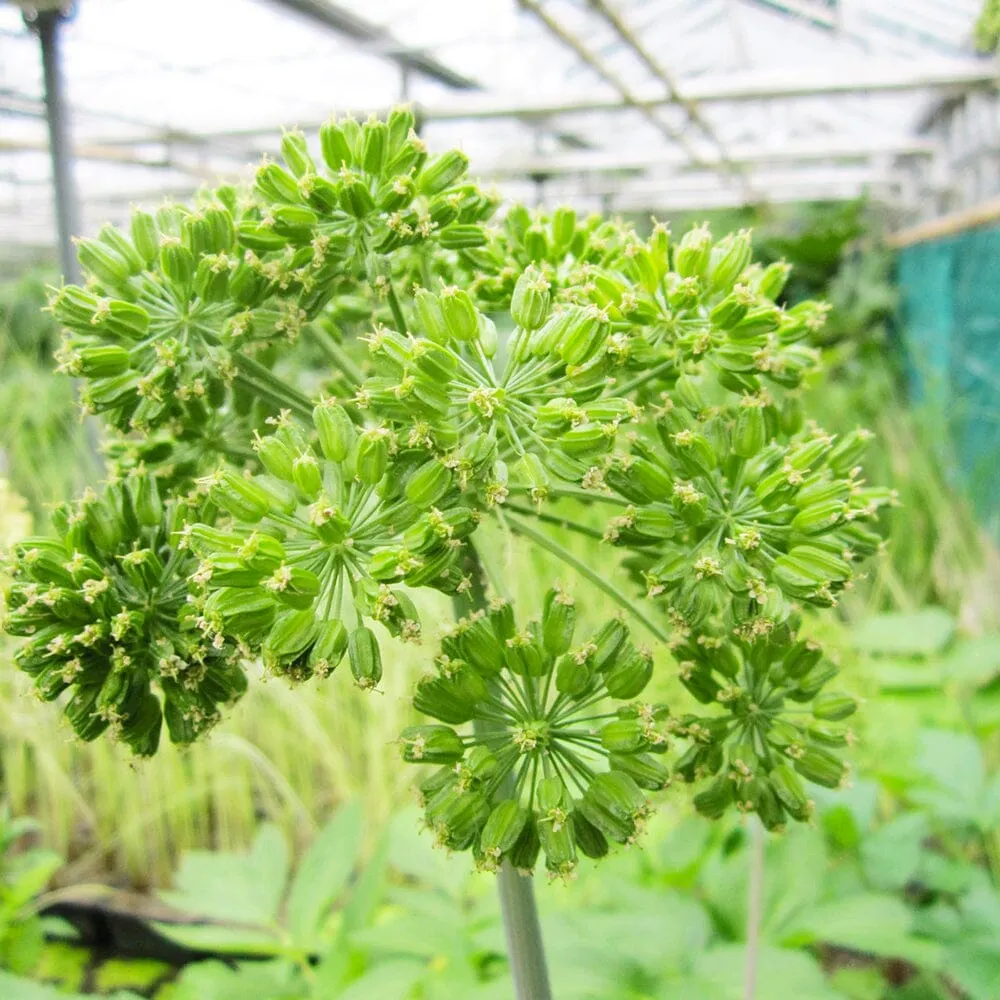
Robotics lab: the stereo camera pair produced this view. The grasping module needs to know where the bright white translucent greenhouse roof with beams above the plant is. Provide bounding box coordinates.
[0,0,996,254]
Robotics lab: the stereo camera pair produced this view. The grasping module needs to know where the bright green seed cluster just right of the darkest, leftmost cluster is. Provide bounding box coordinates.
[178,399,477,687]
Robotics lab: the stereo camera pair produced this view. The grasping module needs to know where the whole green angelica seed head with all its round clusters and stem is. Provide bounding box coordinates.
[0,109,892,997]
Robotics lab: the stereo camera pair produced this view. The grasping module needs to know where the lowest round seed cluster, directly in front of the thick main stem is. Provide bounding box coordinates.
[401,590,674,877]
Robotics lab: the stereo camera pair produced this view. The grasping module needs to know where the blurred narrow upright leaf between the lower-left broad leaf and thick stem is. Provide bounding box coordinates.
[285,802,363,951]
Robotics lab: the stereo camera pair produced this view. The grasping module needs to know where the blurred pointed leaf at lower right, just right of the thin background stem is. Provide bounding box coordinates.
[786,893,942,969]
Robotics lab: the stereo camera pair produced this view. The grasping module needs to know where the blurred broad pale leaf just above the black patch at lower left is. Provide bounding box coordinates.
[160,823,288,927]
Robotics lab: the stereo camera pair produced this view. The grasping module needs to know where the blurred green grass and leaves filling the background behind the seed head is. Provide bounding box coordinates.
[0,202,1000,1000]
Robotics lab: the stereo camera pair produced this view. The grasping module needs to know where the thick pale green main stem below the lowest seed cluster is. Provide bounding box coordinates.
[455,545,552,1000]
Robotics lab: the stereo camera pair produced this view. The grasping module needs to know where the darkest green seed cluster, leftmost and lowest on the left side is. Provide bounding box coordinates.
[4,476,246,755]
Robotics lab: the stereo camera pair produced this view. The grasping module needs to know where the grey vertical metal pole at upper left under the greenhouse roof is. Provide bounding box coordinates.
[28,10,80,282]
